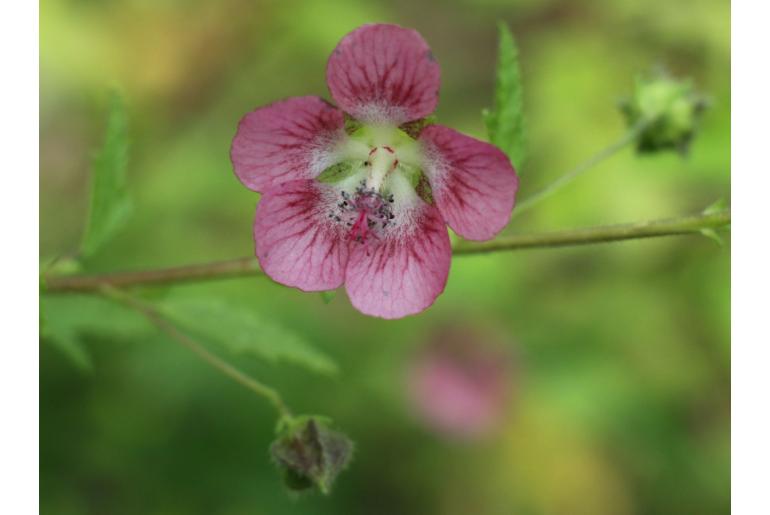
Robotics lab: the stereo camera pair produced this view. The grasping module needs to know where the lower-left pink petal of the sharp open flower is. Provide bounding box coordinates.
[254,180,348,291]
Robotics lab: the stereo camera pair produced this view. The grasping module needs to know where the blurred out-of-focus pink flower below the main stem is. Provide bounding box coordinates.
[408,328,513,439]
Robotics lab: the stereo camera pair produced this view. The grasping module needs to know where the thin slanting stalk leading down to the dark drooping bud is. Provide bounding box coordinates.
[99,283,291,417]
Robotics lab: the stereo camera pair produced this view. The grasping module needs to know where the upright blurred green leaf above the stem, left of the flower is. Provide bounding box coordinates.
[81,92,132,257]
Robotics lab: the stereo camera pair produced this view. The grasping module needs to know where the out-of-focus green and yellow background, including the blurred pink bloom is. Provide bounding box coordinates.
[40,0,730,515]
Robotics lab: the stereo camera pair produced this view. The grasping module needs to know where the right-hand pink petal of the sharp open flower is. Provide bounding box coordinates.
[420,125,519,240]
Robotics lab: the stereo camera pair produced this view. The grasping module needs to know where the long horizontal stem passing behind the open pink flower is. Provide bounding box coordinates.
[46,210,730,293]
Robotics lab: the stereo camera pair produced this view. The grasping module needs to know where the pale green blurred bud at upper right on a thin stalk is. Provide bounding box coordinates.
[620,73,708,154]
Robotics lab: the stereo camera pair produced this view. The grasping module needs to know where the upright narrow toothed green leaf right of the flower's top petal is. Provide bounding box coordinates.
[482,22,526,171]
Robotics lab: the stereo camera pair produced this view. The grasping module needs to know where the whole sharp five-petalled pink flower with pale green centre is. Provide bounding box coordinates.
[230,25,518,318]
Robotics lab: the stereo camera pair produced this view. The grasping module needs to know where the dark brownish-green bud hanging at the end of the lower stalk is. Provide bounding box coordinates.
[270,416,353,494]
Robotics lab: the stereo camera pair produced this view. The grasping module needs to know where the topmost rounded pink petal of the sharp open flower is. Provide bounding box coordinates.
[326,24,440,125]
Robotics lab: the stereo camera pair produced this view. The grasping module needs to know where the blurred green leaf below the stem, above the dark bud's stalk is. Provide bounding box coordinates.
[157,298,337,374]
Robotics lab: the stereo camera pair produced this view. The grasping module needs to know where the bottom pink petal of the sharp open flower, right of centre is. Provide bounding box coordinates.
[345,205,452,318]
